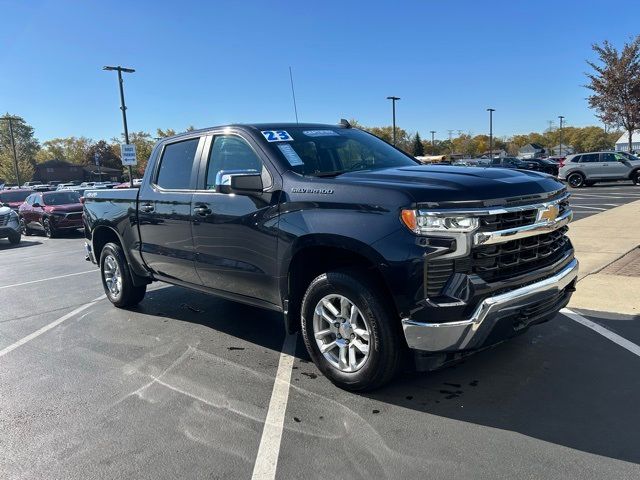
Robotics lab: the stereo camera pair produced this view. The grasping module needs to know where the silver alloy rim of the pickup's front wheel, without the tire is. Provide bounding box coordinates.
[313,294,370,373]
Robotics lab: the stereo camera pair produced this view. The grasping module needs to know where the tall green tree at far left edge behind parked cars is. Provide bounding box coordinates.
[0,113,40,183]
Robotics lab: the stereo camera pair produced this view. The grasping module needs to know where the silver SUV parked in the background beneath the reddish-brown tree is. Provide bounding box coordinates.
[558,152,640,188]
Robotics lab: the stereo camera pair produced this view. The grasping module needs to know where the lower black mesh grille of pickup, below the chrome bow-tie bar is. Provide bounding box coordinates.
[464,227,571,282]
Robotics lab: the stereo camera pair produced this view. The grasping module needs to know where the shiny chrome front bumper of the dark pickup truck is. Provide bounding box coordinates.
[402,259,578,353]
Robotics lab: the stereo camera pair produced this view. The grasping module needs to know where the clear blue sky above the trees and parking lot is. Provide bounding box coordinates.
[0,0,640,140]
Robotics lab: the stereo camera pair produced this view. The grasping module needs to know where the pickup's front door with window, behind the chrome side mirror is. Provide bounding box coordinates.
[192,132,280,305]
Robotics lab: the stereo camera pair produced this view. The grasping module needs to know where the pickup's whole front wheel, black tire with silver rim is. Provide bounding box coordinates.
[301,270,404,391]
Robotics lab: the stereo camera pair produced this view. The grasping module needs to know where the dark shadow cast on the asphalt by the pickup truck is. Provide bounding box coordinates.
[132,287,640,463]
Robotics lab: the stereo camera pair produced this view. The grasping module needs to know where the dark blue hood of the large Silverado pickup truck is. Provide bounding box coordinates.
[336,165,564,207]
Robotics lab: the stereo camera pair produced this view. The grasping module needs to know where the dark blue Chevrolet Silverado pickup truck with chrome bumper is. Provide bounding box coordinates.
[84,121,578,390]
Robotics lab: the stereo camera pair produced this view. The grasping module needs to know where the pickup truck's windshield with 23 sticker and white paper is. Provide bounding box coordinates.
[262,127,418,177]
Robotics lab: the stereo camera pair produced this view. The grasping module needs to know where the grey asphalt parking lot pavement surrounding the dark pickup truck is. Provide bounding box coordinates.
[0,214,640,479]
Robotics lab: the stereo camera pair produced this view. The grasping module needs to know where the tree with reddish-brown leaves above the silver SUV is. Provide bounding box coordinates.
[587,35,640,151]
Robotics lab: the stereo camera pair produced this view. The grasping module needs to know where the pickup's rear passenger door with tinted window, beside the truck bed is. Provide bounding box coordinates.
[138,135,205,284]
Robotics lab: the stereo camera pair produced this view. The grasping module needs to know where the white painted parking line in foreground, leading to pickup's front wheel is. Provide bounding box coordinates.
[251,334,298,480]
